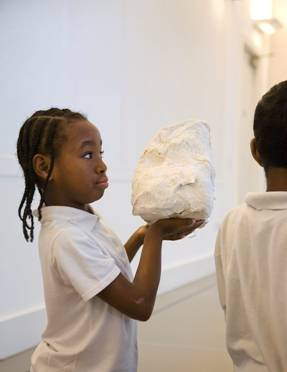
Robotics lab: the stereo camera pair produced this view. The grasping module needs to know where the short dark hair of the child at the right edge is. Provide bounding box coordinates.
[253,81,287,170]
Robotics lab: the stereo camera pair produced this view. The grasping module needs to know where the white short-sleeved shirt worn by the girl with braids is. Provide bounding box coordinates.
[31,206,137,372]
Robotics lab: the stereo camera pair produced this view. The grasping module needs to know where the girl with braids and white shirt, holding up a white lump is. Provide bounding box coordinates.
[17,108,203,372]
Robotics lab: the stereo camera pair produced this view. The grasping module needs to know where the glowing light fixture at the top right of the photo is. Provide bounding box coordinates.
[250,0,282,35]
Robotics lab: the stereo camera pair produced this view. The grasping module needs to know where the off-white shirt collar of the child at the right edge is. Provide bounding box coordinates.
[245,191,287,210]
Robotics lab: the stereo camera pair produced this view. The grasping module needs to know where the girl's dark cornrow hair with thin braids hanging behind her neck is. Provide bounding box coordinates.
[17,108,87,242]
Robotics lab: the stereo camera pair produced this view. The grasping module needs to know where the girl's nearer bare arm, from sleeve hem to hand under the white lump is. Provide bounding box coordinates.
[98,219,202,321]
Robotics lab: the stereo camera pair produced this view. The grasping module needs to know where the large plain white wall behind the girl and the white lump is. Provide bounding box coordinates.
[0,0,270,358]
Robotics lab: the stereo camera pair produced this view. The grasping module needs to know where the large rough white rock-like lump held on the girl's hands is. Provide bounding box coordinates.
[132,120,215,222]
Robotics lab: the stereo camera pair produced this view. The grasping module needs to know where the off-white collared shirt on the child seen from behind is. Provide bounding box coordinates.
[215,192,287,372]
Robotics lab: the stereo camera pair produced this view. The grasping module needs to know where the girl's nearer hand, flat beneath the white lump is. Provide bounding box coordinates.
[149,218,204,240]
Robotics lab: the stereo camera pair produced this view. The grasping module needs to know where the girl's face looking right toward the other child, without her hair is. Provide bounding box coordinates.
[45,120,108,209]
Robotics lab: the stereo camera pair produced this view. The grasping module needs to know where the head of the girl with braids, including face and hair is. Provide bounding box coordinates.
[17,108,108,241]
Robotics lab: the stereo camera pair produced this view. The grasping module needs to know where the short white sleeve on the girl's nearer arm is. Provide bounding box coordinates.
[53,231,120,301]
